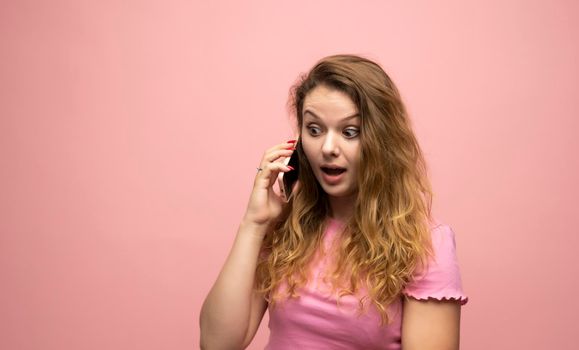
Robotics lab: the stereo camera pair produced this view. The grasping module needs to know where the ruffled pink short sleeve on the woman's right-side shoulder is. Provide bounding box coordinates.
[402,224,468,305]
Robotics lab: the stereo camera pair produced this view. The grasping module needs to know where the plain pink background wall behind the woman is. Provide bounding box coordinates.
[0,0,579,350]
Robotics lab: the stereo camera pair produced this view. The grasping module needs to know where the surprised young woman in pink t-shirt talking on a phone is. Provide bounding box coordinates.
[200,55,467,350]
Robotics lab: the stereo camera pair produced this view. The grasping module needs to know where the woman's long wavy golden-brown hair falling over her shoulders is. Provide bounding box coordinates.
[255,55,432,325]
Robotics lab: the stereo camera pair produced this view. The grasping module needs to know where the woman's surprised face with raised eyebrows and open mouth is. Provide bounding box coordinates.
[301,85,360,198]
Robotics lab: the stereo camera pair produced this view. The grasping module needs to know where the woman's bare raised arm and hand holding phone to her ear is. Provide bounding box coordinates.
[199,140,295,350]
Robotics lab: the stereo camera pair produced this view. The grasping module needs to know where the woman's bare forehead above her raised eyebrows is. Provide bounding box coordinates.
[302,85,358,117]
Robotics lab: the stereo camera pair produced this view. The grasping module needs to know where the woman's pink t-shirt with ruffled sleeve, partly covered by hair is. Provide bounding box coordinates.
[265,219,468,350]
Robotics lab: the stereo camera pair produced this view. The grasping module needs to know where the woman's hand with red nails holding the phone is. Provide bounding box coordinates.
[244,140,295,232]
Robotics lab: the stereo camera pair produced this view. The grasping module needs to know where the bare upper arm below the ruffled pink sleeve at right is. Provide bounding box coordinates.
[402,297,460,350]
